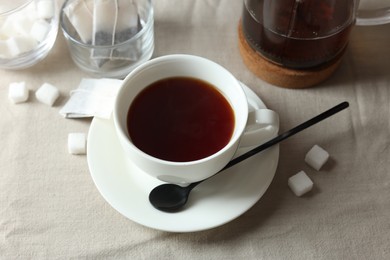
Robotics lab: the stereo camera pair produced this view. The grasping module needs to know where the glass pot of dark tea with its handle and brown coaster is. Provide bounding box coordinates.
[239,0,390,88]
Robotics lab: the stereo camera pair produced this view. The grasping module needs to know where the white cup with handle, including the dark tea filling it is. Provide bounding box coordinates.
[114,55,279,184]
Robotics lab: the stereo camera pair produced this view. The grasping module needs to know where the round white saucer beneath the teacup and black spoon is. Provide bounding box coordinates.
[87,85,279,232]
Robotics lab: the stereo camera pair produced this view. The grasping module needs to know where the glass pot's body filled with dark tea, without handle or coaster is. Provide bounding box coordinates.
[242,0,354,69]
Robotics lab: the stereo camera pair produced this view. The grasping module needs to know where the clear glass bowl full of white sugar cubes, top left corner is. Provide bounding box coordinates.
[0,0,58,69]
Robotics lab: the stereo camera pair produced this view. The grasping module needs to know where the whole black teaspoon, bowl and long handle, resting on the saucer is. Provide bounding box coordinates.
[149,102,349,212]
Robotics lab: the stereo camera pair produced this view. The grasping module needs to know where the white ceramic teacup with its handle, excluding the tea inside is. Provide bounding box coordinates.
[113,54,279,184]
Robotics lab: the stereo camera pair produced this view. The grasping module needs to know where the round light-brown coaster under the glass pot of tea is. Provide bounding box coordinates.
[238,21,342,88]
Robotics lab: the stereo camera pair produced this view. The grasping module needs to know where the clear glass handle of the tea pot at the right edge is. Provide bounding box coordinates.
[356,6,390,25]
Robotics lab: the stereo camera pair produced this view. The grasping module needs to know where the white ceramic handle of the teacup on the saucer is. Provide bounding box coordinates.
[239,109,279,148]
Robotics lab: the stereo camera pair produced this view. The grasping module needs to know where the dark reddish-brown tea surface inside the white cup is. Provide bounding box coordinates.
[127,77,235,162]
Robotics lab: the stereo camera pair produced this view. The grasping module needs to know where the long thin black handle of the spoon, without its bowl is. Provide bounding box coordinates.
[221,101,349,171]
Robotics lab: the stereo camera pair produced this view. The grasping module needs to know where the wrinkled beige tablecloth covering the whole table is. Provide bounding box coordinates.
[0,0,390,259]
